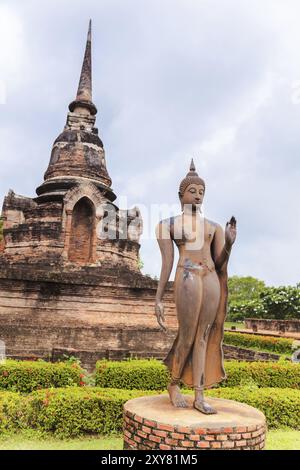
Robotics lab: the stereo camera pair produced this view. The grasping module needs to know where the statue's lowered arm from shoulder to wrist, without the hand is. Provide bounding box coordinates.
[156,221,174,302]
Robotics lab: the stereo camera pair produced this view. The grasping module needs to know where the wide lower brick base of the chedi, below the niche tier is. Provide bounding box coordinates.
[0,268,176,368]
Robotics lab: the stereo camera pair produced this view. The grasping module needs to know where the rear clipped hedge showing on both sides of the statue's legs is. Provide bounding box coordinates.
[96,359,300,390]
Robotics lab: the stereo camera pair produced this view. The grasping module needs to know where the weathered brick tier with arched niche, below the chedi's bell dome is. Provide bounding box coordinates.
[0,188,140,272]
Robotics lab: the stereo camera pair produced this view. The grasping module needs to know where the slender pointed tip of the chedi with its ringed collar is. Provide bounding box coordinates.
[69,20,97,115]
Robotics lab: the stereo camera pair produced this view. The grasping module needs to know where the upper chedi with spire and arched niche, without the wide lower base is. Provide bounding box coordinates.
[2,21,141,271]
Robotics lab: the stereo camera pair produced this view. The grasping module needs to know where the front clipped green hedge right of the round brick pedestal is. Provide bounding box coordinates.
[207,387,300,429]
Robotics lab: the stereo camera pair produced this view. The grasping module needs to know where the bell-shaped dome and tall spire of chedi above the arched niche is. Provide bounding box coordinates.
[37,17,116,201]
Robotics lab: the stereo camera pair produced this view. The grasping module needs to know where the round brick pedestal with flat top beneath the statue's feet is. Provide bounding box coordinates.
[124,395,266,450]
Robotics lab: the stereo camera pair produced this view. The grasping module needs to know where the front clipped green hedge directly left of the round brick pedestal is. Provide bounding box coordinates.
[26,387,151,438]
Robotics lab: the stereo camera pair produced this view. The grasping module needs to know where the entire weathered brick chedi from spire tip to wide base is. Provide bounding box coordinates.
[0,24,176,367]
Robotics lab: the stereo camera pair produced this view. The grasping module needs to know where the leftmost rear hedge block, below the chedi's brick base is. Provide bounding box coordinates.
[0,359,84,393]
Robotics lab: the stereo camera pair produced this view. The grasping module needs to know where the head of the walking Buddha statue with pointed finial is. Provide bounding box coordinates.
[178,159,205,210]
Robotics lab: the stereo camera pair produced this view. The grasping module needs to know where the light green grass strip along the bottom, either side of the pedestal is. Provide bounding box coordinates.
[0,429,300,450]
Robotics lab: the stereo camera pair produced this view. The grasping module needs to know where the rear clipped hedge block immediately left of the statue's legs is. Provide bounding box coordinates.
[95,359,170,390]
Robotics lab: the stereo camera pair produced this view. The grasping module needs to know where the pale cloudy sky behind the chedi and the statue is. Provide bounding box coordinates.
[0,0,300,285]
